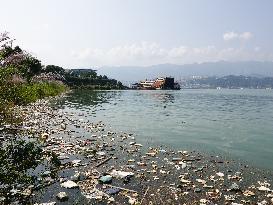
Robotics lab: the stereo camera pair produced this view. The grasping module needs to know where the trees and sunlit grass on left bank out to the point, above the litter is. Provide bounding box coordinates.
[0,32,127,123]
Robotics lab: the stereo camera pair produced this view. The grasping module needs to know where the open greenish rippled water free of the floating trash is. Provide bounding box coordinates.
[54,89,273,169]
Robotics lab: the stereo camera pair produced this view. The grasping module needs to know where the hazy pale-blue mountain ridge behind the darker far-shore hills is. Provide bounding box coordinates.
[98,61,273,83]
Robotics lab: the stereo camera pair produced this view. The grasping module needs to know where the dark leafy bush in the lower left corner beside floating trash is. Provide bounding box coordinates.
[0,136,60,204]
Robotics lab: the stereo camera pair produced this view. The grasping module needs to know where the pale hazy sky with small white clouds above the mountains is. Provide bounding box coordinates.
[0,0,273,69]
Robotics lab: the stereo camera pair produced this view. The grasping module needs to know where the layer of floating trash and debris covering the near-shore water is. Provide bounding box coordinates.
[2,93,273,205]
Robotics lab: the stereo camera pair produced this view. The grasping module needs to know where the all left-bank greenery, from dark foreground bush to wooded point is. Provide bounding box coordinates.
[0,32,125,204]
